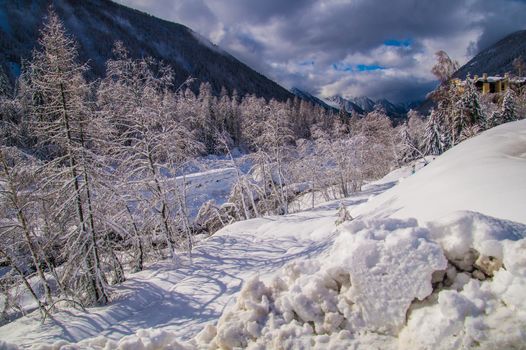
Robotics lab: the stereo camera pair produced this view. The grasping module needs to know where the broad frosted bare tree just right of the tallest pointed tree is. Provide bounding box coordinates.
[98,43,202,259]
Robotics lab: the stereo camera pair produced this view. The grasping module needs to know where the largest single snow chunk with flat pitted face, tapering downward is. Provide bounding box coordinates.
[334,216,447,334]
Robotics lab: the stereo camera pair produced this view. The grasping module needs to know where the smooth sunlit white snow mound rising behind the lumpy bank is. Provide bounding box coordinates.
[351,120,526,223]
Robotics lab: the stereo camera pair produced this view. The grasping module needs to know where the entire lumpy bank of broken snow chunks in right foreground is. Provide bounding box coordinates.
[193,212,526,349]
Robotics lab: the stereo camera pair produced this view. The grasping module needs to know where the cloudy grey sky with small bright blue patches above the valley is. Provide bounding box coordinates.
[116,0,526,102]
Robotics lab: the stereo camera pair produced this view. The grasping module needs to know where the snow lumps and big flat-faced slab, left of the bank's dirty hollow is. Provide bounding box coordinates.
[195,220,447,349]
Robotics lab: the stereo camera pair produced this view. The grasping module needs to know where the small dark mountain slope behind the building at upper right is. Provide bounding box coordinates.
[453,30,526,79]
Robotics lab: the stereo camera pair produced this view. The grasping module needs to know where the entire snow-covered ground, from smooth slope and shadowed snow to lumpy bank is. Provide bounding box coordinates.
[0,120,526,349]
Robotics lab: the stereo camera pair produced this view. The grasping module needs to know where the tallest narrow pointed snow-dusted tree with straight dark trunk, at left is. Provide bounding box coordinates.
[24,10,107,304]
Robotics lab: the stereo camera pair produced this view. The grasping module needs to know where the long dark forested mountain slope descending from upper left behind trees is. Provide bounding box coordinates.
[0,0,293,101]
